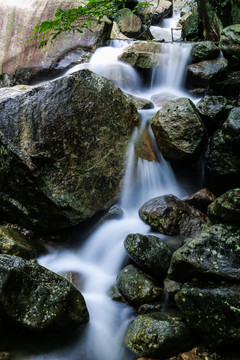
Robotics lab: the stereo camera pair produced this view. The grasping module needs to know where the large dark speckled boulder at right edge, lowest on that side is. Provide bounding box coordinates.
[175,283,240,347]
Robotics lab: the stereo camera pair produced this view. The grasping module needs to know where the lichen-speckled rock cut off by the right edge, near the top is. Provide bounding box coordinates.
[219,24,240,63]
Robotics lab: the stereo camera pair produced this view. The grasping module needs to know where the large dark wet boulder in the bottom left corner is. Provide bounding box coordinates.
[0,255,89,335]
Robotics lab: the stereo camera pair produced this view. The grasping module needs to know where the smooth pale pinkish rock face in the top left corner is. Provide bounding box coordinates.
[0,0,109,79]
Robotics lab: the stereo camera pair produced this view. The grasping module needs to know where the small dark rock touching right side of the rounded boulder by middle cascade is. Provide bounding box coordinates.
[197,95,227,133]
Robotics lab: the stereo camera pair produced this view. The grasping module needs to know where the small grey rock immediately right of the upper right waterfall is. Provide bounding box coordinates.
[192,41,220,62]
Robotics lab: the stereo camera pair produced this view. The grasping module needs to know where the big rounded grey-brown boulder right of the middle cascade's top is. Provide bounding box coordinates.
[150,98,206,164]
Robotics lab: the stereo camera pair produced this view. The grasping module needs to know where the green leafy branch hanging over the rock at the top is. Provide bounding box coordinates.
[28,0,149,48]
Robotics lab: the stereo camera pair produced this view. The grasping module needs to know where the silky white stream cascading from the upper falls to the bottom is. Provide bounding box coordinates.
[21,41,202,360]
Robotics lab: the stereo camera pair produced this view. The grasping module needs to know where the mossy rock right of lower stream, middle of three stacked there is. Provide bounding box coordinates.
[117,265,163,306]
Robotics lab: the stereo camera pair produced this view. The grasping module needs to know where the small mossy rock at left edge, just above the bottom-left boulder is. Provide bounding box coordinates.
[0,225,40,259]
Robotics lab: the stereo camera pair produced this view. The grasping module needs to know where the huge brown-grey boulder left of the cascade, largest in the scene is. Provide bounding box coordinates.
[0,70,139,230]
